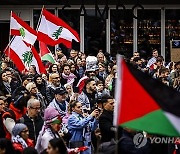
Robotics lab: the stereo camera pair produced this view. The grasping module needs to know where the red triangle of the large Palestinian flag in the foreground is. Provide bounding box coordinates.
[119,61,160,124]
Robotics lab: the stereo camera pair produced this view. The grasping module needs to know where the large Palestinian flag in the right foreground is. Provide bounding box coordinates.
[114,57,180,136]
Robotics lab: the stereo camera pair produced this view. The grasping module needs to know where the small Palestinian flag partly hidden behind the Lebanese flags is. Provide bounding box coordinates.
[39,41,55,64]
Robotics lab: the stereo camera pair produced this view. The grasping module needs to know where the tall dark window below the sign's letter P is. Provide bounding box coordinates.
[110,10,133,58]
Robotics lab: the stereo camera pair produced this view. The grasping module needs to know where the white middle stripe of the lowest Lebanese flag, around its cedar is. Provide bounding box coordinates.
[10,36,40,73]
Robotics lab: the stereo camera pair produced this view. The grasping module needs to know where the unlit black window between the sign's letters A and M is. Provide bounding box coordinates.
[84,9,106,56]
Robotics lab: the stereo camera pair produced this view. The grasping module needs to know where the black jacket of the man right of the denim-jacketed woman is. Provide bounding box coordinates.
[99,109,115,142]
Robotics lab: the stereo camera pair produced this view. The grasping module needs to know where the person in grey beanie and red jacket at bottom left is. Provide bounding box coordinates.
[11,123,34,152]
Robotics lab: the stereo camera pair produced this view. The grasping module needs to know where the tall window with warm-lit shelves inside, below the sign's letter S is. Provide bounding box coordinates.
[137,9,161,58]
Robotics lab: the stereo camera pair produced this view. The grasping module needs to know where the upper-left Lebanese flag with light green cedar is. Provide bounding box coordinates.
[10,12,37,45]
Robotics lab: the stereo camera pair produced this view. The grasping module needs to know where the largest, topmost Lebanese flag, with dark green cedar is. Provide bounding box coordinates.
[37,8,80,48]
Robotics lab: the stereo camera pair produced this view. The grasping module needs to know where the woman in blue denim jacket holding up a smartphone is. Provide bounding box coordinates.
[68,101,99,154]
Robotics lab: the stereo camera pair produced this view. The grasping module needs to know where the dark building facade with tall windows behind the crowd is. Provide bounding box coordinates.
[0,4,180,61]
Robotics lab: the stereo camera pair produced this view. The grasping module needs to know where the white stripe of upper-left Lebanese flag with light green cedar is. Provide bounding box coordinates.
[10,17,37,45]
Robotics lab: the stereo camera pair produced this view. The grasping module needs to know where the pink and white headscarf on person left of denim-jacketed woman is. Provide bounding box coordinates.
[44,107,60,124]
